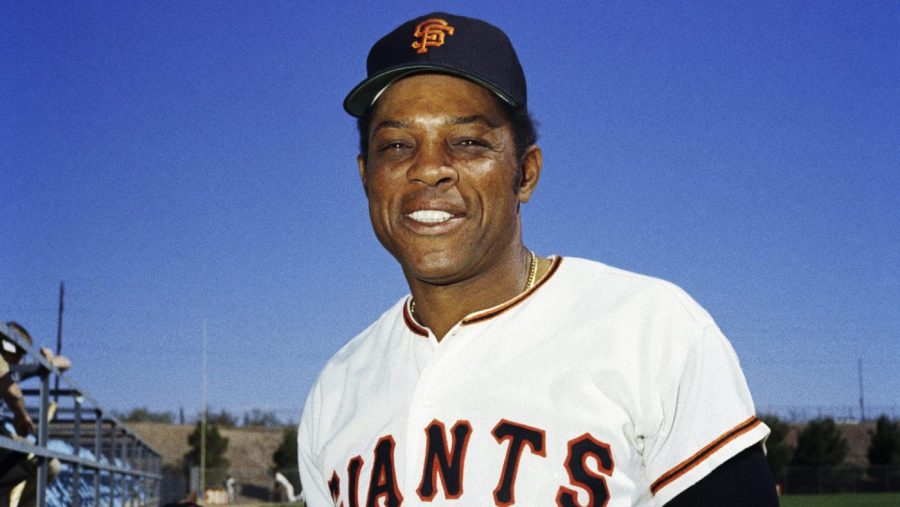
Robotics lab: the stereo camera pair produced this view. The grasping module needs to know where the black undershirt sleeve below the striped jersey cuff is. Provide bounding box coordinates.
[666,445,778,507]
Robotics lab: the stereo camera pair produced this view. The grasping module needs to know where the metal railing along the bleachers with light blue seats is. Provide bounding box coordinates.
[0,322,162,507]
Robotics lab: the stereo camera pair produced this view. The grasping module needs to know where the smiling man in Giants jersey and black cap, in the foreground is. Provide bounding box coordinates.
[298,13,777,507]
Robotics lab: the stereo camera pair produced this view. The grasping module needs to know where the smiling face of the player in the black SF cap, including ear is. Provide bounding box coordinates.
[359,74,540,284]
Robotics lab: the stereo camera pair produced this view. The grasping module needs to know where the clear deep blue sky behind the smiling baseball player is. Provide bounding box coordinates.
[0,2,900,419]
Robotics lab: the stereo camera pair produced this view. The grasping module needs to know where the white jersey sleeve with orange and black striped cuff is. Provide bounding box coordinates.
[645,324,769,505]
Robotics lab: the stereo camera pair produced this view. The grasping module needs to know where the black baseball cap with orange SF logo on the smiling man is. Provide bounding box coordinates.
[344,12,527,117]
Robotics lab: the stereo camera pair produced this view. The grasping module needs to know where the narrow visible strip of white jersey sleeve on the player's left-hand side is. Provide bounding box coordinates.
[297,383,334,507]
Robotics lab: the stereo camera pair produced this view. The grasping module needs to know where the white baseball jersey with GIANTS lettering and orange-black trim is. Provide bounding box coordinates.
[298,257,769,507]
